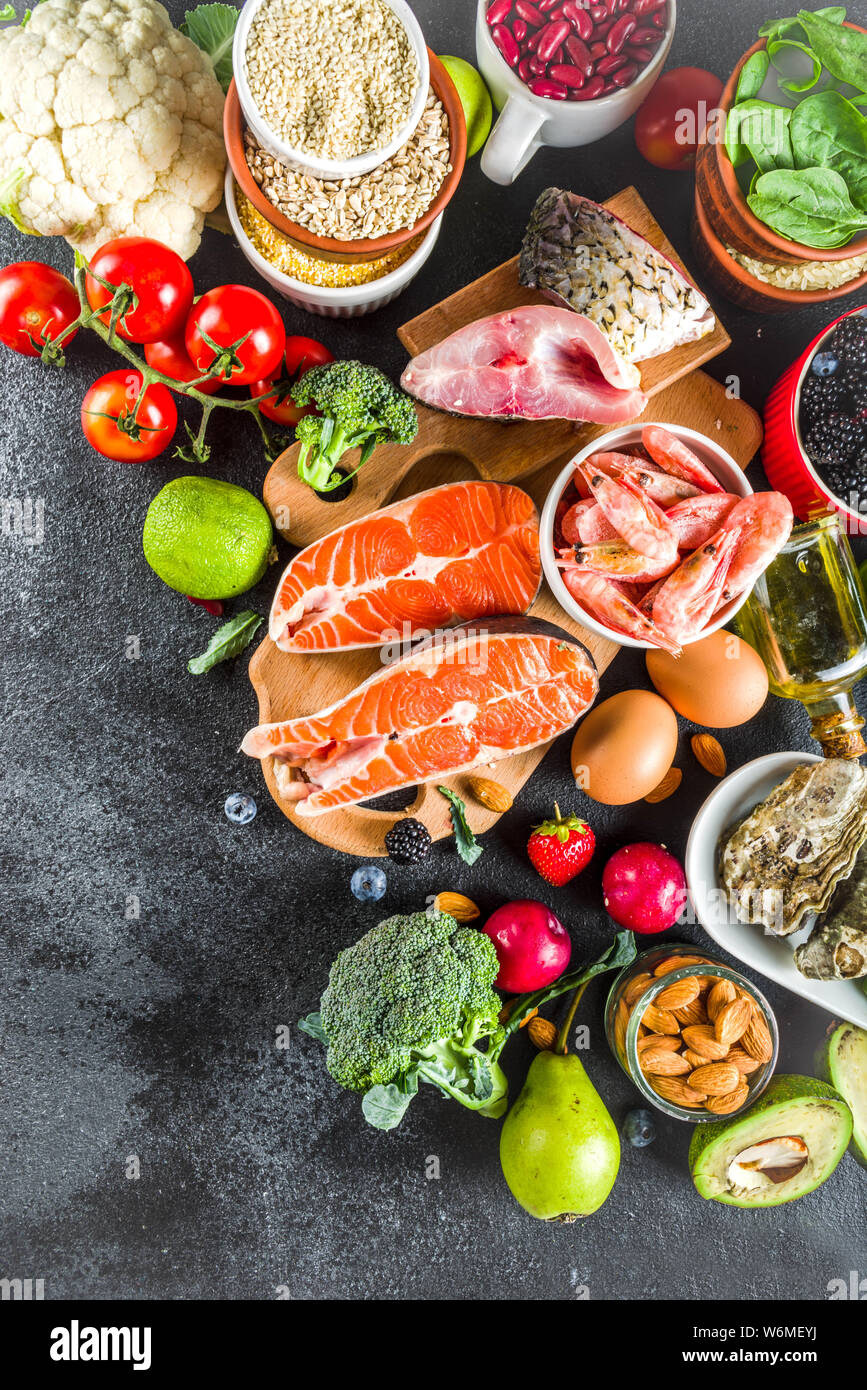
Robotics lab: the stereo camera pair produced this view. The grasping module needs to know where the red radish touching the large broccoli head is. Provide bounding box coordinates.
[482,898,572,994]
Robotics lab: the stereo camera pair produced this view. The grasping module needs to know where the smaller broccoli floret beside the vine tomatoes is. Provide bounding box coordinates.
[292,361,418,492]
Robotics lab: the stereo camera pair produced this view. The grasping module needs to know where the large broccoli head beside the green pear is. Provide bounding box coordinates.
[311,912,506,1115]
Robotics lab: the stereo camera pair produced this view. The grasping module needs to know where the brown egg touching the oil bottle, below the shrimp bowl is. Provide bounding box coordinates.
[647,631,767,728]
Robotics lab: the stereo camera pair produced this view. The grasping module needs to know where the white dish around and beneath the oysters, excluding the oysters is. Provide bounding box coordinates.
[686,752,867,1027]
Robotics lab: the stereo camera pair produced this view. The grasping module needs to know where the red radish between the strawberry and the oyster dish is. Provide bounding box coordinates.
[602,841,686,934]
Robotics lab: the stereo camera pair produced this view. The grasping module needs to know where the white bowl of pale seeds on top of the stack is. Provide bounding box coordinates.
[232,0,429,179]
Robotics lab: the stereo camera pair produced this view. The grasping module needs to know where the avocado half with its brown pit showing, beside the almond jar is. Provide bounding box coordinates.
[689,1076,852,1207]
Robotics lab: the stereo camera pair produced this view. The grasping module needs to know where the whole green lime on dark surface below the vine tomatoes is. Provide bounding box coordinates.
[142,478,274,599]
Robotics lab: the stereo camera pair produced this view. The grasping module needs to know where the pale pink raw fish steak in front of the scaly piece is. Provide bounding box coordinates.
[400,304,647,424]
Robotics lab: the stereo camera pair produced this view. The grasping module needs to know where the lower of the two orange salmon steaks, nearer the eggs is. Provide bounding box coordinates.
[240,617,599,816]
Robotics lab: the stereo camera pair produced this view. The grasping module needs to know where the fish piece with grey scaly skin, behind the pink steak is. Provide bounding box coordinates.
[518,188,716,361]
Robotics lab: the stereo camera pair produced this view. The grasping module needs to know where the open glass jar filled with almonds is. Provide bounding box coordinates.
[606,941,779,1125]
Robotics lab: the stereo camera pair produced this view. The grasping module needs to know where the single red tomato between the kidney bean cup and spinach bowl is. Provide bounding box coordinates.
[635,68,723,170]
